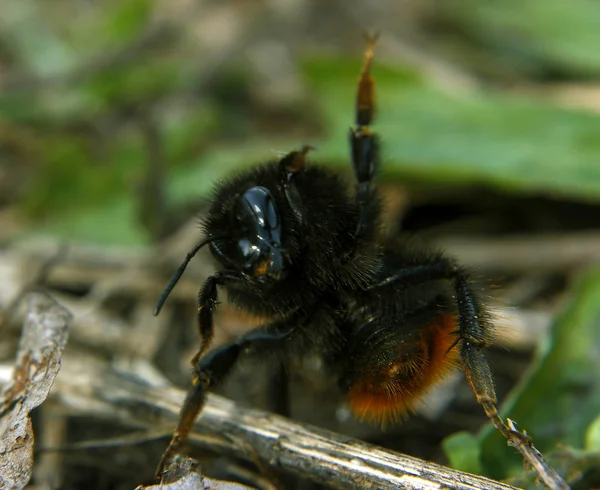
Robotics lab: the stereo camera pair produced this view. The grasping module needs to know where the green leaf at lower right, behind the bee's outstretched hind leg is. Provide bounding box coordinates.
[480,270,600,478]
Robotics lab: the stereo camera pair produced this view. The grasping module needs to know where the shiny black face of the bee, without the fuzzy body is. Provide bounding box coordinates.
[210,186,285,279]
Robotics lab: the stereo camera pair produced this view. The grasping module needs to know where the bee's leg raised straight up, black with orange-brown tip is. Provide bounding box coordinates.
[350,35,379,237]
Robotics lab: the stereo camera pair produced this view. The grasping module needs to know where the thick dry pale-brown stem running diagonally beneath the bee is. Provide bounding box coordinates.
[42,355,524,490]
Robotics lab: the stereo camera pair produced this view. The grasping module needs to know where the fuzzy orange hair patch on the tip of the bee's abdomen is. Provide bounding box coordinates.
[348,314,459,424]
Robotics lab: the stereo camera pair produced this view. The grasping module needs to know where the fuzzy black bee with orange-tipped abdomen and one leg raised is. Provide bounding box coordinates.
[154,36,518,475]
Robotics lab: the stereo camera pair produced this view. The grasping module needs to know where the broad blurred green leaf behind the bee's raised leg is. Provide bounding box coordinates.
[305,60,600,202]
